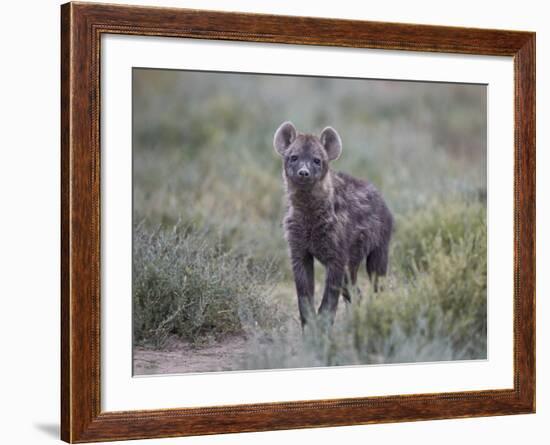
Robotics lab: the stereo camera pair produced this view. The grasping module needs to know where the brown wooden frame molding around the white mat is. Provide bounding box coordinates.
[61,3,535,443]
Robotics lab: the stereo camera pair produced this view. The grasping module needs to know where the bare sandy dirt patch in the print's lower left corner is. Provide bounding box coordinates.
[134,337,253,375]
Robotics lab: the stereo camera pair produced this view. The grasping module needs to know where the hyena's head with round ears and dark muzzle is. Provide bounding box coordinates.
[273,122,342,188]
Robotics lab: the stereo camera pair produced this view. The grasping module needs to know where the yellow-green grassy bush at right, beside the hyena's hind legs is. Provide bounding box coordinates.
[244,199,487,369]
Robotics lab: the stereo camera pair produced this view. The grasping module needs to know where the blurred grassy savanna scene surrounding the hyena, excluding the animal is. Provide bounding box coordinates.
[133,69,487,374]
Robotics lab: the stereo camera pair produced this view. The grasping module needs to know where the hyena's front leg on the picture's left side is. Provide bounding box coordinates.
[292,252,315,327]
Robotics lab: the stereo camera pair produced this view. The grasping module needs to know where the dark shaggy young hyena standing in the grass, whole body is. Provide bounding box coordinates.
[273,122,393,326]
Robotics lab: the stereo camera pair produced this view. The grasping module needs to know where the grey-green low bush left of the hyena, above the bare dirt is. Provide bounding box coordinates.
[133,224,285,347]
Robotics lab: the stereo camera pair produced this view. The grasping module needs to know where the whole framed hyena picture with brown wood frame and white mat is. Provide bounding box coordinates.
[61,3,535,443]
